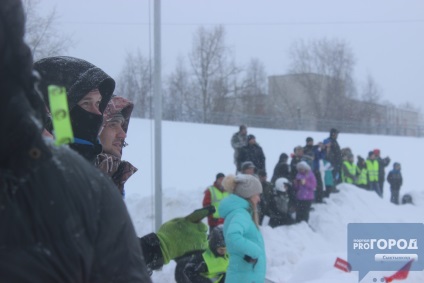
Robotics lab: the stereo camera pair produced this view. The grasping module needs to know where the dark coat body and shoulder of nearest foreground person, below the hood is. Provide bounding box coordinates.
[0,143,150,283]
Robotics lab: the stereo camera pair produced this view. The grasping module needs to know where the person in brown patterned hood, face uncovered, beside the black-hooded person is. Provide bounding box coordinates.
[95,96,137,196]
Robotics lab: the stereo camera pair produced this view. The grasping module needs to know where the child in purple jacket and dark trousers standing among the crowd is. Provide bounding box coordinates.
[293,161,317,222]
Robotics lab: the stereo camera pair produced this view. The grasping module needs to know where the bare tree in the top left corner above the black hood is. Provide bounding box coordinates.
[23,0,73,60]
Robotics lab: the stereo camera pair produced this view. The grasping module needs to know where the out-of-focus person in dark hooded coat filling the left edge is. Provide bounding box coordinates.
[0,0,150,283]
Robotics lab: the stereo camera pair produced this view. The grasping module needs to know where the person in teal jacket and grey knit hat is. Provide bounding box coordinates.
[218,174,266,283]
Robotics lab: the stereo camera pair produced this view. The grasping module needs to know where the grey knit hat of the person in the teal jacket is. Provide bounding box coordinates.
[222,174,262,199]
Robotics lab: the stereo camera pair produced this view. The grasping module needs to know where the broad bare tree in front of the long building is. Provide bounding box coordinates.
[290,38,355,127]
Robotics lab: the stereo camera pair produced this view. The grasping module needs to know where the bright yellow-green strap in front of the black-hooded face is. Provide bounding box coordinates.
[48,85,74,145]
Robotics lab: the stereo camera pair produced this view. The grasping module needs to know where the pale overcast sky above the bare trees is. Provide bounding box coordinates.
[40,0,424,110]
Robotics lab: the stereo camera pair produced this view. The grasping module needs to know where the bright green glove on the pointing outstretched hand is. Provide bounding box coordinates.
[156,218,208,264]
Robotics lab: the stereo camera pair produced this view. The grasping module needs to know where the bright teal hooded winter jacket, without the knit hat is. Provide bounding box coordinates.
[218,194,266,283]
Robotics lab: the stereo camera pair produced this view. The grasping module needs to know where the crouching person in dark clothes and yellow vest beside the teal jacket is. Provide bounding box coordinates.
[175,225,230,283]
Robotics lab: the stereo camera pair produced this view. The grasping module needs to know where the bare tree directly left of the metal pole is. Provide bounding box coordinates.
[117,51,152,118]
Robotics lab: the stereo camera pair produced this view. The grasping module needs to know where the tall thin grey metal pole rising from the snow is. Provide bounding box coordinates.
[153,0,162,231]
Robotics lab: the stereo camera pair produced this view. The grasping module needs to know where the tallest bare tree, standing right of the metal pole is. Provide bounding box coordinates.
[189,26,240,122]
